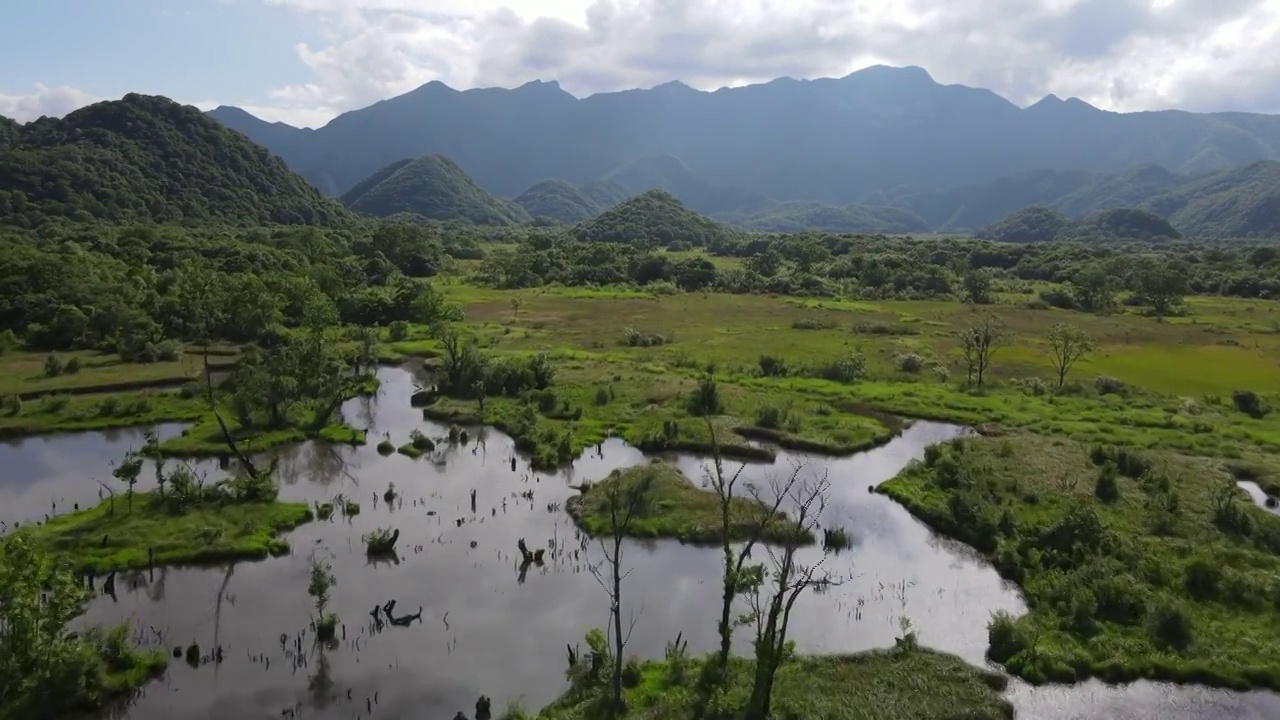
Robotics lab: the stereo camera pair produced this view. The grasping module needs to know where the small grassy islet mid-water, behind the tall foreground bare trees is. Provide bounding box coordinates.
[564,461,814,544]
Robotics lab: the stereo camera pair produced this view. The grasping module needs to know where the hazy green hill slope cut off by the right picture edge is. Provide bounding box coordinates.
[1142,161,1280,238]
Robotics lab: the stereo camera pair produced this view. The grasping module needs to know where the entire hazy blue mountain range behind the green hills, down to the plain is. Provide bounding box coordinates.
[210,65,1280,234]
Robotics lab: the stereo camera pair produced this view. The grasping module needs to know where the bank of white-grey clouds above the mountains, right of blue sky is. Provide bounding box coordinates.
[251,0,1280,126]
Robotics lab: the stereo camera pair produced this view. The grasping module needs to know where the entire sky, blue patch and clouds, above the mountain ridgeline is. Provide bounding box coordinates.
[0,0,1280,127]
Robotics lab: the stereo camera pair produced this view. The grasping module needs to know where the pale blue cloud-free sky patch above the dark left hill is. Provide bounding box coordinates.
[0,0,320,110]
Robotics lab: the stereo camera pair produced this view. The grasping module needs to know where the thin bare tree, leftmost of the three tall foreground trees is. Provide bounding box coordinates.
[588,471,653,715]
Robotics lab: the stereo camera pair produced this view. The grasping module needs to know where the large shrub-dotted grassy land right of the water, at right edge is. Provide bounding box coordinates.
[879,434,1280,689]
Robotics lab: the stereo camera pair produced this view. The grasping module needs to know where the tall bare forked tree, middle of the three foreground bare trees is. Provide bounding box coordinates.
[707,419,801,673]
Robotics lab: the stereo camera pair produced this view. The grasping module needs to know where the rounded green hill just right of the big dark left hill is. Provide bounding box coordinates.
[343,155,531,225]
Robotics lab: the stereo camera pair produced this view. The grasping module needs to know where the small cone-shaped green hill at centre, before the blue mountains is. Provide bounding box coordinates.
[573,190,736,246]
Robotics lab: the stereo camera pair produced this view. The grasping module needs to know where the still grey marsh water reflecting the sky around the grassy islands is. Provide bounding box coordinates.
[0,368,1280,720]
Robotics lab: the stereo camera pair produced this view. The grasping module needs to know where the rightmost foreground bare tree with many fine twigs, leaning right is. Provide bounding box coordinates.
[746,464,835,720]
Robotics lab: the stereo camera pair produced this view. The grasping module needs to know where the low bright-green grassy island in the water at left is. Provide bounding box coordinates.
[19,487,312,573]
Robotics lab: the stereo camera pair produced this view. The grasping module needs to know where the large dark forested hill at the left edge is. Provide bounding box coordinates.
[0,94,349,225]
